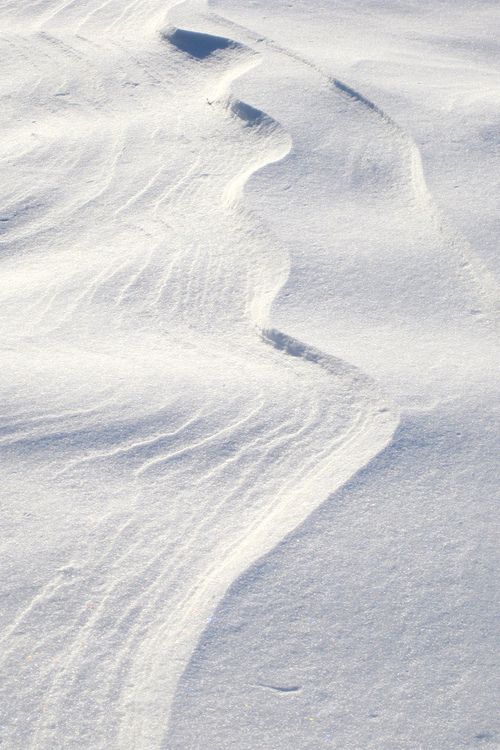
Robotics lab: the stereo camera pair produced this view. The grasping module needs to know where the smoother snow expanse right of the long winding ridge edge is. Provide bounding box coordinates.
[164,0,499,750]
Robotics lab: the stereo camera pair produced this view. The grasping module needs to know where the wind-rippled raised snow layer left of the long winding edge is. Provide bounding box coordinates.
[0,2,397,750]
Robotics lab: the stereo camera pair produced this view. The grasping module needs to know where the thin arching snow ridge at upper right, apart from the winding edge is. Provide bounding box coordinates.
[204,8,500,316]
